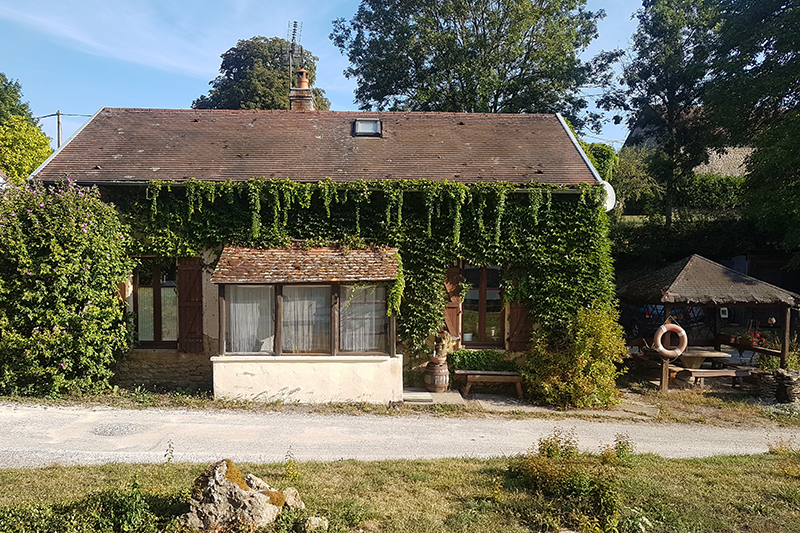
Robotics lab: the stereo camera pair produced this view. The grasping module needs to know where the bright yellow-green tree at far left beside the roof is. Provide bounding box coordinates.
[0,115,53,185]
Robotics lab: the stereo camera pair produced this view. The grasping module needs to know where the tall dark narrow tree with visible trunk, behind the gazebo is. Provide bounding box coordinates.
[601,0,716,226]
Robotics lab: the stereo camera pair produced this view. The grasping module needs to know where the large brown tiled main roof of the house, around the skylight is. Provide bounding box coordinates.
[38,108,596,186]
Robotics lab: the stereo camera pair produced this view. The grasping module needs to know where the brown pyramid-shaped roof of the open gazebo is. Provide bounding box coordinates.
[617,254,800,307]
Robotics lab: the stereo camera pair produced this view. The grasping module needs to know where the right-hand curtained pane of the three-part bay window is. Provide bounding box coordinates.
[339,285,389,353]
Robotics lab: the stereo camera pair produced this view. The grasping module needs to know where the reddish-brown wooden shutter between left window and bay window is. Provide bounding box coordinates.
[178,257,203,353]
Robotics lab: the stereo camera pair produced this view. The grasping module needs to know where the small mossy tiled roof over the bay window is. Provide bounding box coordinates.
[211,244,398,283]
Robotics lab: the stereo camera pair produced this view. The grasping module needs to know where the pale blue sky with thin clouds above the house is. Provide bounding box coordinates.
[0,0,641,147]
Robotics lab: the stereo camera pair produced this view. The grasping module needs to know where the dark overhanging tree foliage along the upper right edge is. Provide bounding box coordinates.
[707,0,800,250]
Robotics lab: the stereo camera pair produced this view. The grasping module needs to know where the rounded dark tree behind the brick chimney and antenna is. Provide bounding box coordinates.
[192,36,330,110]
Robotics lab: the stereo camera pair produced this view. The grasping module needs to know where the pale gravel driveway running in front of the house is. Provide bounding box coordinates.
[0,404,797,468]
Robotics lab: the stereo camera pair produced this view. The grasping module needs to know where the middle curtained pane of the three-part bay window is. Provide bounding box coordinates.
[282,285,331,353]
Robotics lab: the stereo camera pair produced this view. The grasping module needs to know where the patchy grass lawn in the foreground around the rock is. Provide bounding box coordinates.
[0,449,800,533]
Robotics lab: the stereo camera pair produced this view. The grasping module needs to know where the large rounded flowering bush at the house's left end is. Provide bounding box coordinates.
[0,182,132,395]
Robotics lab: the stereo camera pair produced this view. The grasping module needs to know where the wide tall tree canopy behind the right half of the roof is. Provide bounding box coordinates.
[330,0,617,130]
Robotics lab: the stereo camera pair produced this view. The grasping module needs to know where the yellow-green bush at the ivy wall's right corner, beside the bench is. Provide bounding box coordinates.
[523,307,625,407]
